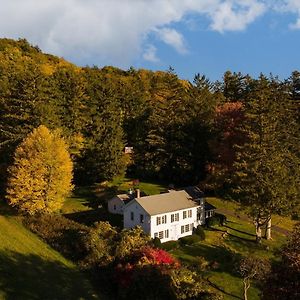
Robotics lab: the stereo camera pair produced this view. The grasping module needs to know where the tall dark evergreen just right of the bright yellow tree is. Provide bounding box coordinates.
[77,68,125,183]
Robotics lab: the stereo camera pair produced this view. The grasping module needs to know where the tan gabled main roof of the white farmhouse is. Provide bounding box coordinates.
[135,191,199,216]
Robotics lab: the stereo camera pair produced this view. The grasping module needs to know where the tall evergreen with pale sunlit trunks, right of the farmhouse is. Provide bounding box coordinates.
[233,76,300,241]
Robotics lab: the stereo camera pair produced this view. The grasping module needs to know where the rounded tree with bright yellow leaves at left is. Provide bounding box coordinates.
[6,125,73,215]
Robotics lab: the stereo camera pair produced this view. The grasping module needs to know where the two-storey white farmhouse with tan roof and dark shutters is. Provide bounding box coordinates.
[124,187,215,242]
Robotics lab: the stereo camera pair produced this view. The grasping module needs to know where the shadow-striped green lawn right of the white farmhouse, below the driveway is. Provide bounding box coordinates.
[171,212,286,300]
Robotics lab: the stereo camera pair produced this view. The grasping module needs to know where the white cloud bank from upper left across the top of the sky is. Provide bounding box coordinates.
[0,0,294,67]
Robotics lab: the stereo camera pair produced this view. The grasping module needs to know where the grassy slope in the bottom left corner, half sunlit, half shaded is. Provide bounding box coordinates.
[0,204,97,299]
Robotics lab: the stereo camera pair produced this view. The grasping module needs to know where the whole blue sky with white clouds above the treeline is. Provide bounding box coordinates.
[0,0,300,80]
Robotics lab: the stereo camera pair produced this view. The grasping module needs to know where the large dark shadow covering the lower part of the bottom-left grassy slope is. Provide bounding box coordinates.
[0,250,98,300]
